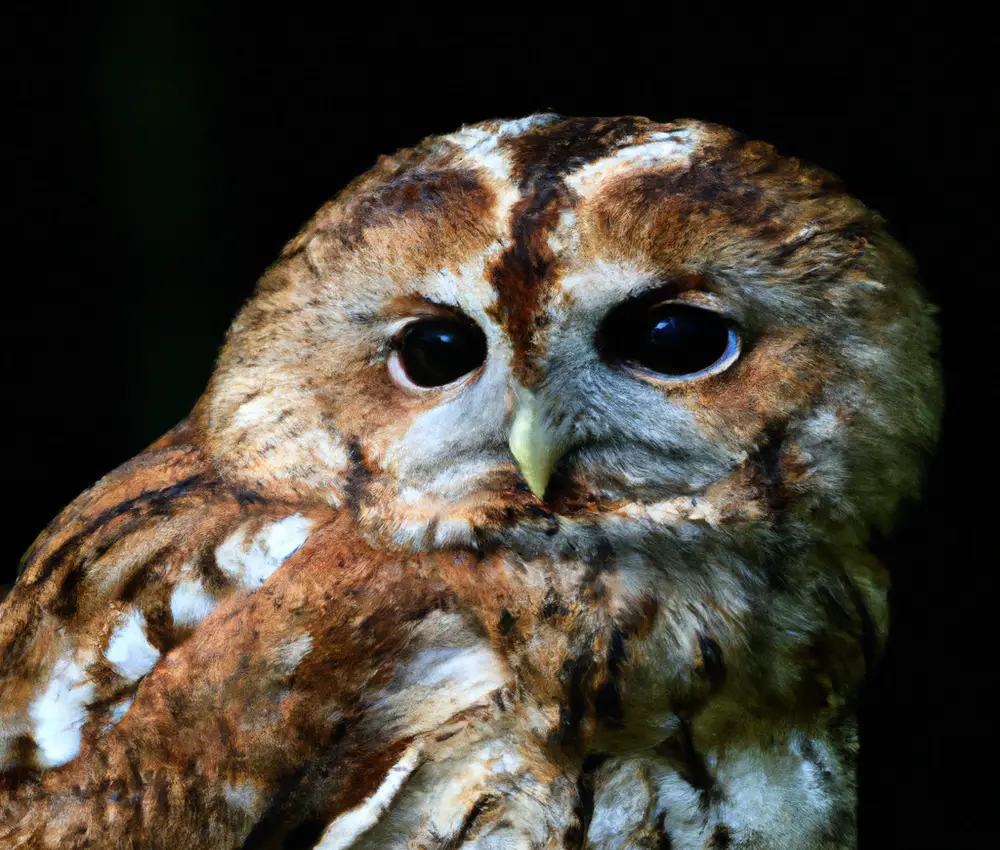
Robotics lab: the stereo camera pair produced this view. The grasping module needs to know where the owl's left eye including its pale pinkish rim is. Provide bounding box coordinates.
[387,315,487,392]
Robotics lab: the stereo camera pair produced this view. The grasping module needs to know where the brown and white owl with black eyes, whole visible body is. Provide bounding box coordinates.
[0,114,940,850]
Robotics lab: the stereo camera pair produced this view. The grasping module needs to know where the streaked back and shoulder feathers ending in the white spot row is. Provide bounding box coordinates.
[0,427,336,774]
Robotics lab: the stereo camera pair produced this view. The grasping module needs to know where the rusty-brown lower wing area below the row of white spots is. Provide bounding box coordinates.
[0,516,488,848]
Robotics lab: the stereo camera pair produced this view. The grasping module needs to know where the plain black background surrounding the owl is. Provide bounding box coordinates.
[7,8,997,848]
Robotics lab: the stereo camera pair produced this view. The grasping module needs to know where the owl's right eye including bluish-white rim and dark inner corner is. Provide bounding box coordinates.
[600,304,740,380]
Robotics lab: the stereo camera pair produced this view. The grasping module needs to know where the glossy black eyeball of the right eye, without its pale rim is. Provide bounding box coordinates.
[618,304,729,375]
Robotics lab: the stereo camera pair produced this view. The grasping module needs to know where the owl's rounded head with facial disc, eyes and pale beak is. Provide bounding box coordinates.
[196,115,939,550]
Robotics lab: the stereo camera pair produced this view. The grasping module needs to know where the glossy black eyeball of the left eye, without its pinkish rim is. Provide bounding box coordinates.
[399,319,486,387]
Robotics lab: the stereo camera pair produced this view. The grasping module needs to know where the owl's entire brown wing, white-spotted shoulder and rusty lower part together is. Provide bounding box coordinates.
[0,422,512,848]
